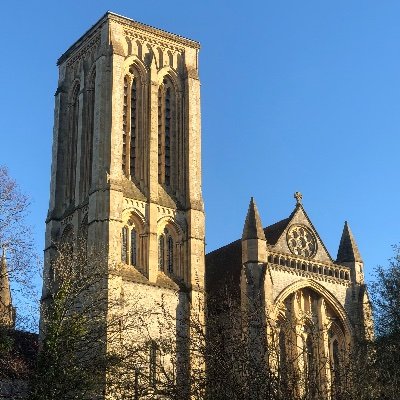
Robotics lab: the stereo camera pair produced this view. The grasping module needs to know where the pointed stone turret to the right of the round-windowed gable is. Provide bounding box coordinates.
[336,221,364,284]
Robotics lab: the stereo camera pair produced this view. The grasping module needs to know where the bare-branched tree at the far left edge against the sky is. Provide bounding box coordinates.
[0,166,38,398]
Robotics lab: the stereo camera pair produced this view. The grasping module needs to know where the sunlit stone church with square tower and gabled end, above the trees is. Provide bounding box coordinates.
[42,12,371,399]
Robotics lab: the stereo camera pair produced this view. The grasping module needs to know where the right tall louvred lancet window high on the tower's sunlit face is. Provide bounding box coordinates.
[158,78,175,186]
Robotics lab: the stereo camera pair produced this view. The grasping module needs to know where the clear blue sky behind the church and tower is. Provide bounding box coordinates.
[0,0,400,292]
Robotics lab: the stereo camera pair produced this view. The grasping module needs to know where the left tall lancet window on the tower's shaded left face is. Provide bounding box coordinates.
[65,85,80,204]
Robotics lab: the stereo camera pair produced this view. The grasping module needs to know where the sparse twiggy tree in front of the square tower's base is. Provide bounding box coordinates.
[30,240,183,400]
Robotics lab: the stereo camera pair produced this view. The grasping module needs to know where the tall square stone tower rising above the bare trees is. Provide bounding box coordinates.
[44,12,204,396]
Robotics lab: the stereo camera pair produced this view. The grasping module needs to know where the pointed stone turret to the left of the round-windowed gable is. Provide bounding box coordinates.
[242,197,267,264]
